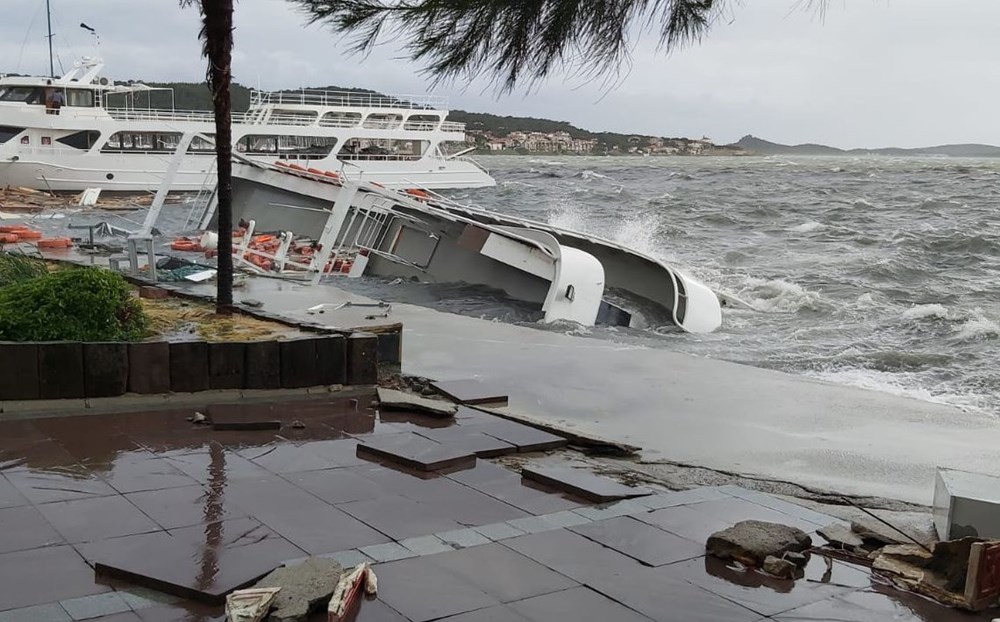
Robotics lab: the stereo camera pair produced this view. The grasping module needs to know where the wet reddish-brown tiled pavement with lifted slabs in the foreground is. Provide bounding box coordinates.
[0,393,991,622]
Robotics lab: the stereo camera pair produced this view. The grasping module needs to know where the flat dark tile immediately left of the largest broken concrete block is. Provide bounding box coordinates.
[570,516,705,566]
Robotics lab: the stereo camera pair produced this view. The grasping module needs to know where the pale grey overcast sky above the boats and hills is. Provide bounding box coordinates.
[0,0,1000,147]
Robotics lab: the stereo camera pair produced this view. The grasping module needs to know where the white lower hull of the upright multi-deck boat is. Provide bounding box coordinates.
[0,150,495,192]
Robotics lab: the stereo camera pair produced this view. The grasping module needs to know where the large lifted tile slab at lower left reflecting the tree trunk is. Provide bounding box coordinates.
[78,518,303,604]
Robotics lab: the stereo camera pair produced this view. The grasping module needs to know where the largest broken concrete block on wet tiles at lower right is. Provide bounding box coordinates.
[705,520,812,568]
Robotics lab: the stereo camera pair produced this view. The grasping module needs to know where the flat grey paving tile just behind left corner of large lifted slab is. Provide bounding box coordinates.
[38,496,160,543]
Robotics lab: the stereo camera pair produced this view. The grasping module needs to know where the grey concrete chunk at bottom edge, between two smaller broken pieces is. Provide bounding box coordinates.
[254,557,343,622]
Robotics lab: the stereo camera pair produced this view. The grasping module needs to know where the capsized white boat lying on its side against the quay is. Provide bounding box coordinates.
[200,160,722,333]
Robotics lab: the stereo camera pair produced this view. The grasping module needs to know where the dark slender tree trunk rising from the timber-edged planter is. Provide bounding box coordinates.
[202,0,233,315]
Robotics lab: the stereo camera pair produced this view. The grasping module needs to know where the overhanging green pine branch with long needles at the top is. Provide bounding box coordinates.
[289,0,727,92]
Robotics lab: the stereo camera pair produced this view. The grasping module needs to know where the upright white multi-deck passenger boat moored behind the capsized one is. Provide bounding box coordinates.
[0,58,496,192]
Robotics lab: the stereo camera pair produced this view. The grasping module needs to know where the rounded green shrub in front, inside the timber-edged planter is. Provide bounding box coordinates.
[0,268,149,341]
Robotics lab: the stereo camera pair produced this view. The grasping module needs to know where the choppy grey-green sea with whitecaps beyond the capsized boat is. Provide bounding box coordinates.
[380,156,1000,420]
